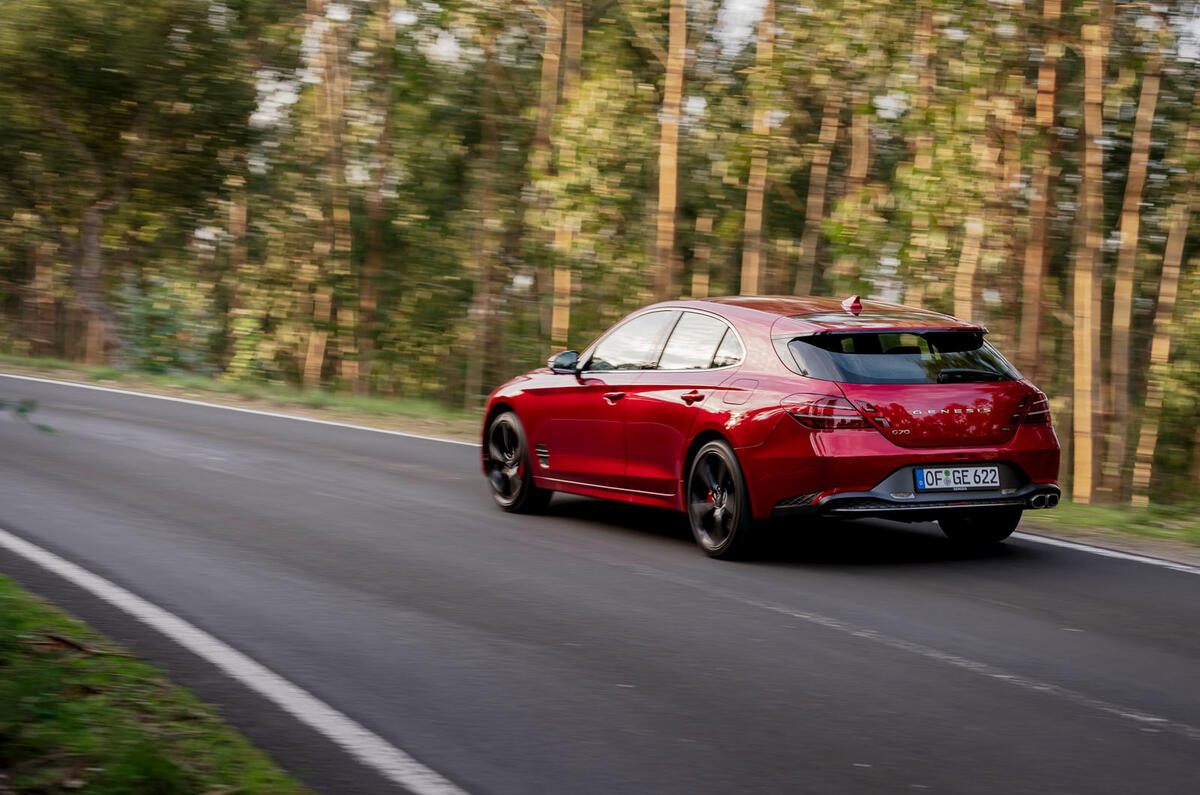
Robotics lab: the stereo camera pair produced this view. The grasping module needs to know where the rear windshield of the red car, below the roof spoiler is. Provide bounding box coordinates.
[780,331,1021,384]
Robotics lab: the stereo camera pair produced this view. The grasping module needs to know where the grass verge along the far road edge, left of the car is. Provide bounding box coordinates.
[0,354,480,441]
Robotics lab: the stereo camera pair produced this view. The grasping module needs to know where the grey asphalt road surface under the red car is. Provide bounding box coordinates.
[0,377,1200,795]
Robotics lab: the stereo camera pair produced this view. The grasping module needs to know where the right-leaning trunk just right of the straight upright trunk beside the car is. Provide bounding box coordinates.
[1104,54,1163,496]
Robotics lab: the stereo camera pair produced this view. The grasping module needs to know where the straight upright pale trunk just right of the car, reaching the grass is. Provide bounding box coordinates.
[1072,17,1104,504]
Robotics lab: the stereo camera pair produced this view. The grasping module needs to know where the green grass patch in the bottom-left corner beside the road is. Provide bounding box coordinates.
[0,576,308,795]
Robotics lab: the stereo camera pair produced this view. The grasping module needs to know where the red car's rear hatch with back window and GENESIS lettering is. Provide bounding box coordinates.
[780,329,1034,447]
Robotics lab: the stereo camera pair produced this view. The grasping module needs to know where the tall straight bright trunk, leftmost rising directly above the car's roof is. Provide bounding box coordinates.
[654,0,688,300]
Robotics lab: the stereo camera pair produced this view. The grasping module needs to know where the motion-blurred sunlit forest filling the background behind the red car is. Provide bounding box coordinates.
[0,0,1200,506]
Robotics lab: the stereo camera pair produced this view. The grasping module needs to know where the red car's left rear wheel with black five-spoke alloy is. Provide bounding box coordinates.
[688,441,754,558]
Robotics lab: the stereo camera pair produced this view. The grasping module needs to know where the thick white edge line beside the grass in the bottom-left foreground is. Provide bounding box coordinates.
[0,528,466,795]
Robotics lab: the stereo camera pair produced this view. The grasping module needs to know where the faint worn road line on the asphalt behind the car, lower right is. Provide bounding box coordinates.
[635,567,1200,742]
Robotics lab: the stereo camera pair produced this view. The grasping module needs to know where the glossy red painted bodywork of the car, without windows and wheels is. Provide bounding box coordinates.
[485,297,1058,519]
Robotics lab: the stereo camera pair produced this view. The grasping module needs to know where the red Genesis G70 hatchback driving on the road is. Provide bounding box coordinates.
[482,295,1060,557]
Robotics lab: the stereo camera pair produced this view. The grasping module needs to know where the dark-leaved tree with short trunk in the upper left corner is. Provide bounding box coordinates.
[0,0,253,363]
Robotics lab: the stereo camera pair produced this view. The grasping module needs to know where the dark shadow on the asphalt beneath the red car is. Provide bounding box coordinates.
[546,495,1030,567]
